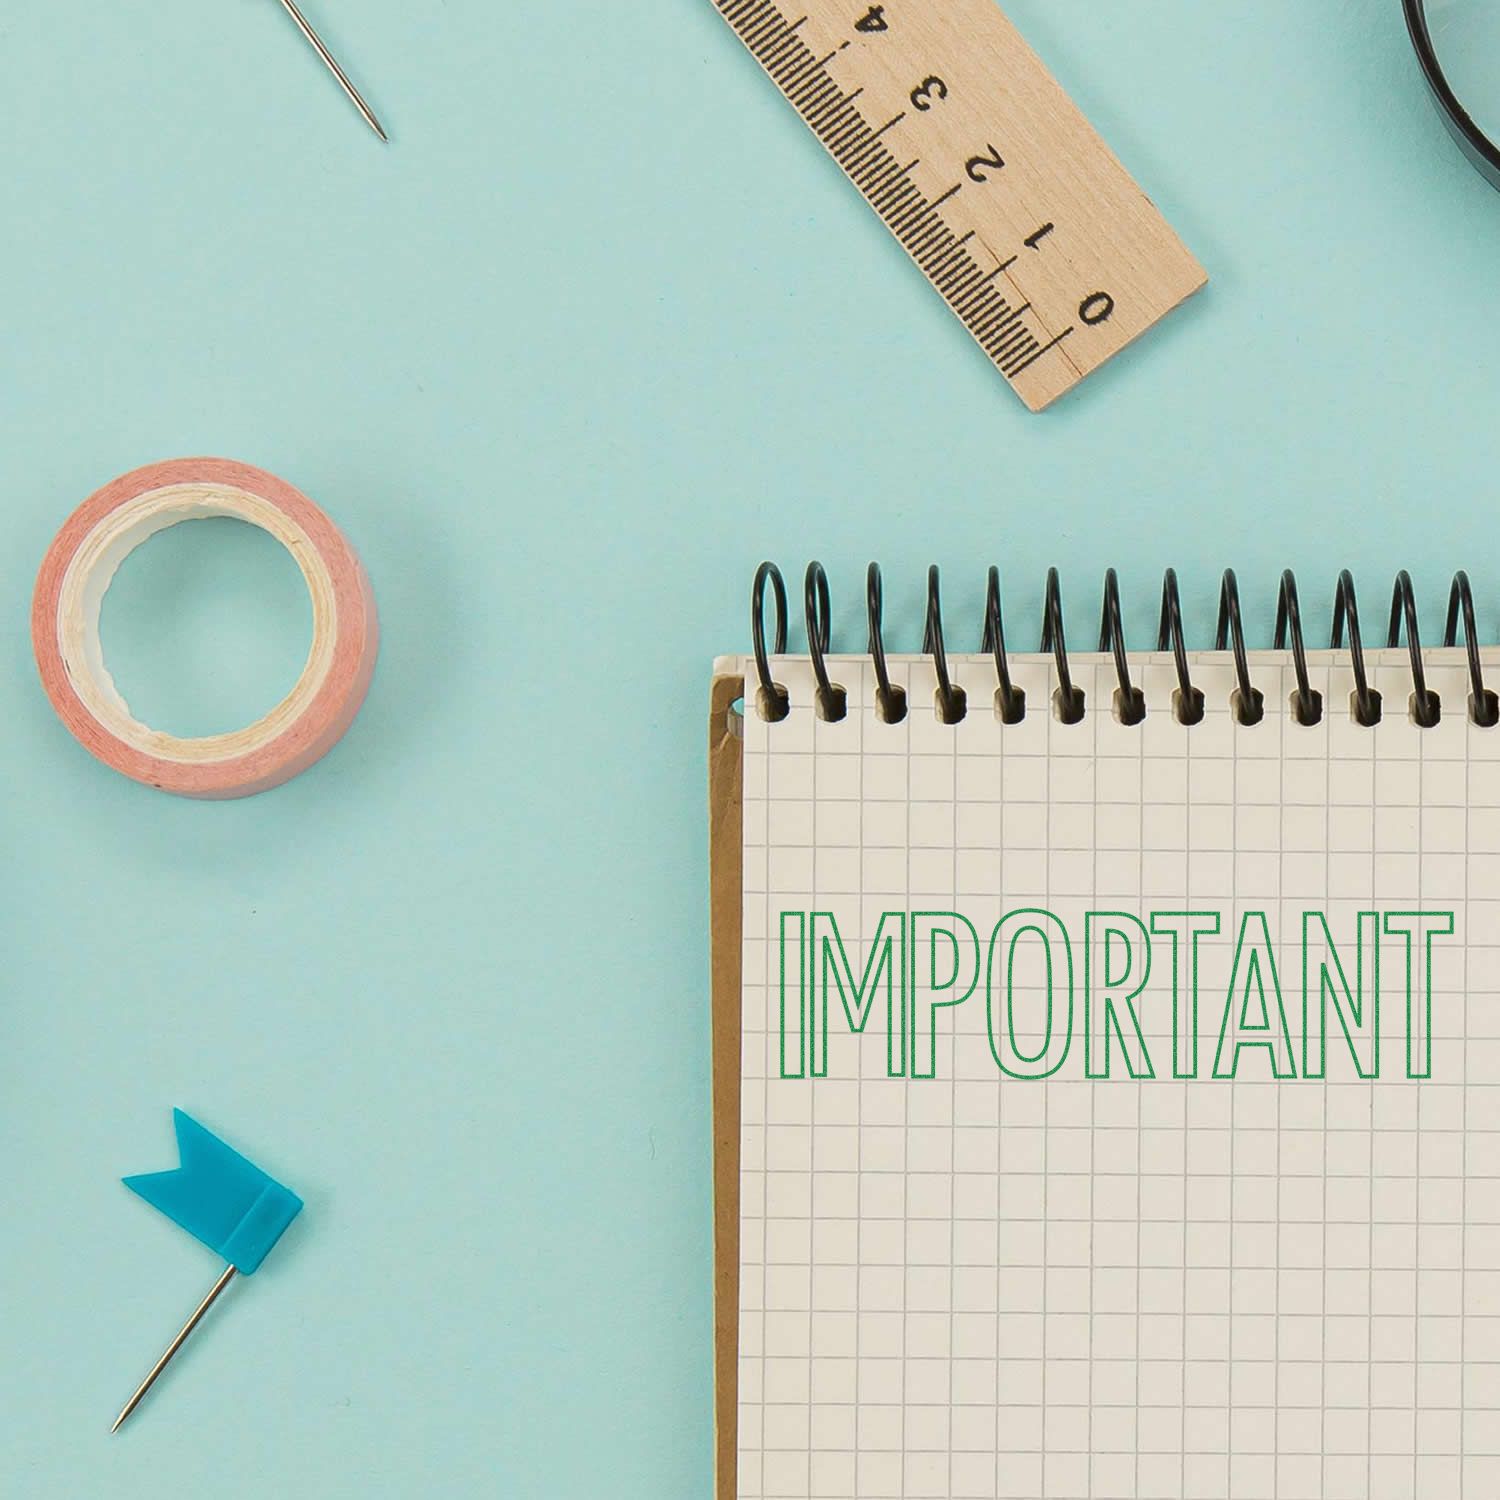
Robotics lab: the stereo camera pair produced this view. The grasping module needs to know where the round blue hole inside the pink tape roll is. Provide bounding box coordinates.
[99,516,312,738]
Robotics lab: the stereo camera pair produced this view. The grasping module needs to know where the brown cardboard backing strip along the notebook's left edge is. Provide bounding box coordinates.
[708,677,744,1500]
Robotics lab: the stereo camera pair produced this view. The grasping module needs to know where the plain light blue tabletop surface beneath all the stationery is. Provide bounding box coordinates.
[0,0,1500,1500]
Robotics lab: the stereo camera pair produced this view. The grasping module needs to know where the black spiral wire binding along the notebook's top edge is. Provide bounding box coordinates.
[750,563,1500,729]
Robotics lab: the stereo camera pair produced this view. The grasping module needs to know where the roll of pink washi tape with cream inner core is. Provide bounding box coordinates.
[32,459,378,798]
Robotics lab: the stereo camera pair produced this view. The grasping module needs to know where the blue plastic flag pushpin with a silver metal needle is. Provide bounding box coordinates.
[110,1110,302,1433]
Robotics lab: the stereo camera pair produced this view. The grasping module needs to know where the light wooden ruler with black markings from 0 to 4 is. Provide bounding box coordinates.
[714,0,1208,411]
